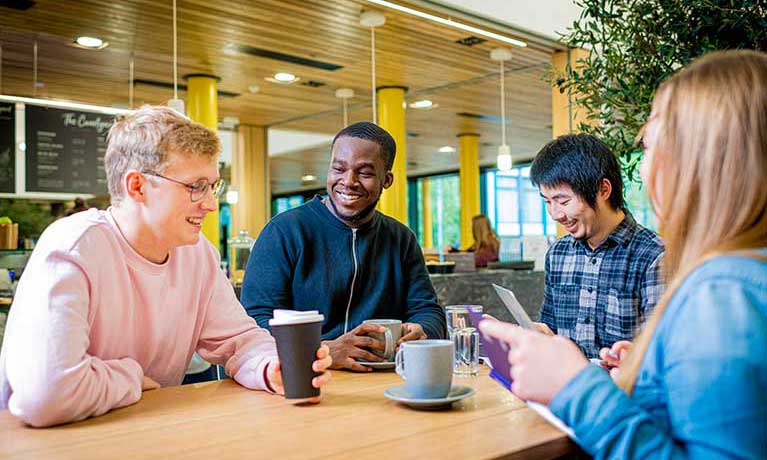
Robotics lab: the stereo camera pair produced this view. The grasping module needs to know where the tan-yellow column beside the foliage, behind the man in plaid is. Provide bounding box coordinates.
[551,48,589,238]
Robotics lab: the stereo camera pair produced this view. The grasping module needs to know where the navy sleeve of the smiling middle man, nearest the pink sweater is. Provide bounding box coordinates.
[240,220,295,330]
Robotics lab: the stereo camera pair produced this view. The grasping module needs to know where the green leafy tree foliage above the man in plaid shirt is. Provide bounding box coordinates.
[554,0,767,179]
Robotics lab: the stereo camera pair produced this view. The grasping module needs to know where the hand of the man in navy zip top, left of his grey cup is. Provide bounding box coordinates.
[323,323,386,372]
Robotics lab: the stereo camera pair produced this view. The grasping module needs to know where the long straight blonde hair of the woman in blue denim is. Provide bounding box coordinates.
[618,51,767,394]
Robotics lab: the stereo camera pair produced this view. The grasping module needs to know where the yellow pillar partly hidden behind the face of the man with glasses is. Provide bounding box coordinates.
[184,74,221,250]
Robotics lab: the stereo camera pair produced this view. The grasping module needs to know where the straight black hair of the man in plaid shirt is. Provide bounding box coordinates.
[530,134,624,209]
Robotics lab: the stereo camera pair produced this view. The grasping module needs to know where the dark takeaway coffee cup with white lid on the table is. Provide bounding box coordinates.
[269,310,325,399]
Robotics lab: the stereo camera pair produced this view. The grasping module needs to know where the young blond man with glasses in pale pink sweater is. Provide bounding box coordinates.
[0,106,331,426]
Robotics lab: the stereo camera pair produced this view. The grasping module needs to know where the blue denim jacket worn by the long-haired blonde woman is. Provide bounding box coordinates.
[550,250,767,459]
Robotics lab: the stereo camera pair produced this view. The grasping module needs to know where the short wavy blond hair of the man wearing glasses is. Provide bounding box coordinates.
[104,105,221,203]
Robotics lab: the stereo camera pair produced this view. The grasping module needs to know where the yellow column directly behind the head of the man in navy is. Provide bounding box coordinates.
[377,86,407,225]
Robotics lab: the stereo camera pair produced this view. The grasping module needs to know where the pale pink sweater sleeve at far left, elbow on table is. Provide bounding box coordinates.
[3,251,144,427]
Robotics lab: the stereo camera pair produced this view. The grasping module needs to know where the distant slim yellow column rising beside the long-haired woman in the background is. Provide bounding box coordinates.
[458,133,480,249]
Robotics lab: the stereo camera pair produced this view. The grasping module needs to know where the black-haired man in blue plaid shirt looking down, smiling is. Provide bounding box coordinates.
[530,134,663,358]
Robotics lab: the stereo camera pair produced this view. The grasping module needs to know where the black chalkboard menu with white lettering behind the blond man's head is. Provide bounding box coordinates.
[25,105,114,195]
